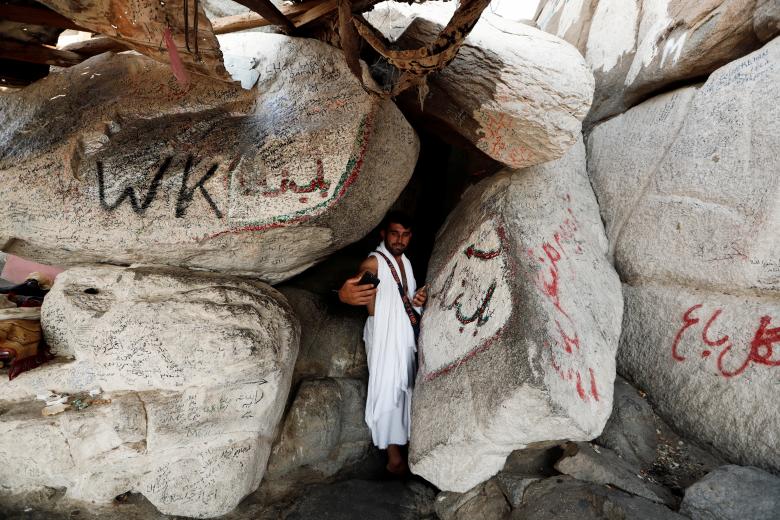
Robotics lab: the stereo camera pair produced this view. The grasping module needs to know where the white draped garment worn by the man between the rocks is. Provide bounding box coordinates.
[363,242,419,449]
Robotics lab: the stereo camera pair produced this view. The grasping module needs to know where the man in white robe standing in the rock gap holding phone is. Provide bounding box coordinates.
[339,212,427,474]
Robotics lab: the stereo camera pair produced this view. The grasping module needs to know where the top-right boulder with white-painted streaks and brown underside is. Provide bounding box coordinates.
[537,0,780,122]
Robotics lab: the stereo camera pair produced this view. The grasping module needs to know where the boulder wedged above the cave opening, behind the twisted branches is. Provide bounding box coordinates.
[368,2,593,168]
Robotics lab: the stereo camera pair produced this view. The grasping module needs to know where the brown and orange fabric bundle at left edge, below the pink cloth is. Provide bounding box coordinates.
[0,307,54,380]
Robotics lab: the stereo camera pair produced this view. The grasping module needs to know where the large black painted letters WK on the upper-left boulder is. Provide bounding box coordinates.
[97,156,222,218]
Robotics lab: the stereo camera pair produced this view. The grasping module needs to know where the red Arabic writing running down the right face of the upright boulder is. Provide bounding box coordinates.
[526,194,600,401]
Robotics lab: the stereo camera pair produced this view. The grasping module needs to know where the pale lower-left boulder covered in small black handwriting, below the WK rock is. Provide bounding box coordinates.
[0,266,300,518]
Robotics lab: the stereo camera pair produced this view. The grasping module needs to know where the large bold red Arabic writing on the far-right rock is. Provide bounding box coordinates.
[672,303,780,377]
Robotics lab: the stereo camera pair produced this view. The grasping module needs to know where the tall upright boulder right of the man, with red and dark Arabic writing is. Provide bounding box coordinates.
[410,140,622,492]
